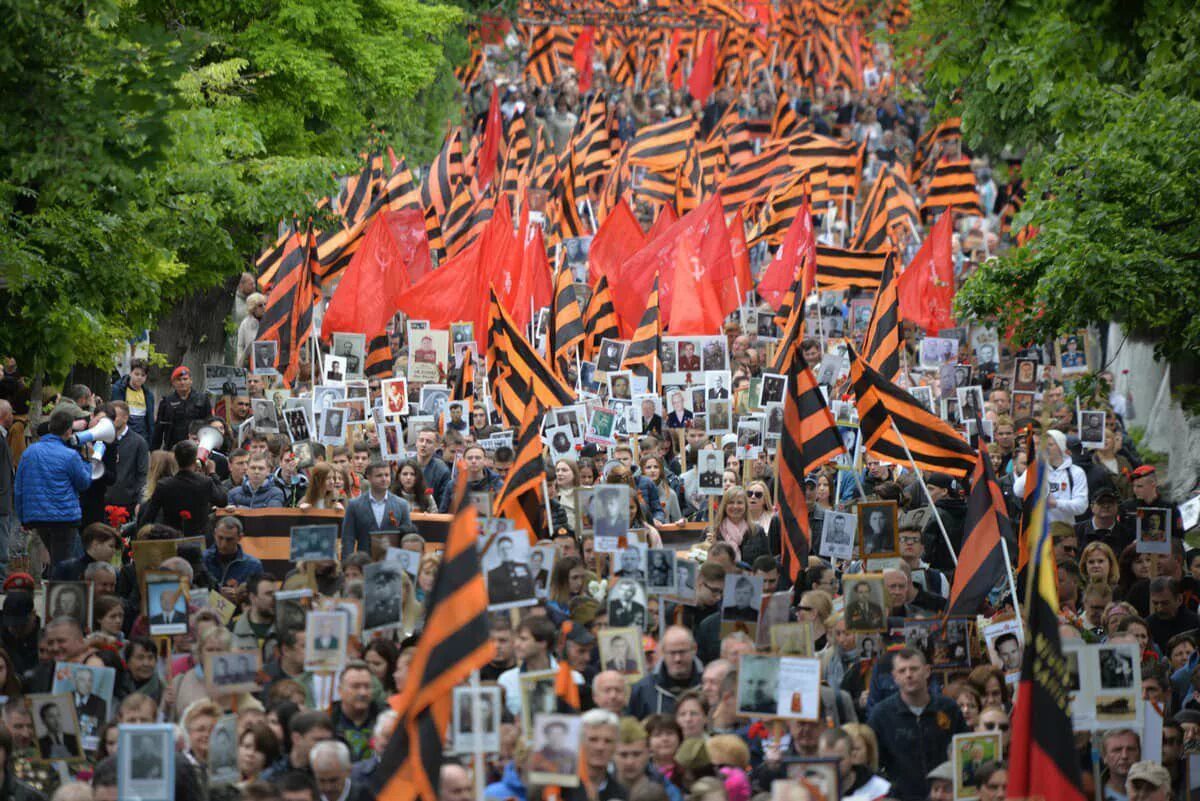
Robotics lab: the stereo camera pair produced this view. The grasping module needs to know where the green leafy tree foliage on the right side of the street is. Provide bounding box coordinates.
[904,0,1200,357]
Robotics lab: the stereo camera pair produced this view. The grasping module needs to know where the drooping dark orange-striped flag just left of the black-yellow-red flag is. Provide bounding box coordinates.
[946,436,1013,616]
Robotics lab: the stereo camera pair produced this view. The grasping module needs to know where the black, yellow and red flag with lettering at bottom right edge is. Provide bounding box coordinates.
[1007,465,1087,801]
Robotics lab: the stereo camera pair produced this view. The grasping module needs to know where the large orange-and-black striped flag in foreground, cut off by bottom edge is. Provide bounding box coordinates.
[373,479,496,801]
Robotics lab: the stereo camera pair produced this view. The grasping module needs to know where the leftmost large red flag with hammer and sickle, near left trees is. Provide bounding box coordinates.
[322,209,433,342]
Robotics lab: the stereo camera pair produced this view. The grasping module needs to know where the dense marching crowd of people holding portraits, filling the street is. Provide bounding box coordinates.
[0,1,1200,801]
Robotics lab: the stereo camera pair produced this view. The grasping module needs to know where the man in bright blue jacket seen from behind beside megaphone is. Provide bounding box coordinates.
[14,410,91,564]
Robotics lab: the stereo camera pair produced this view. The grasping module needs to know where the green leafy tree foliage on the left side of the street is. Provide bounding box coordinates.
[0,0,462,373]
